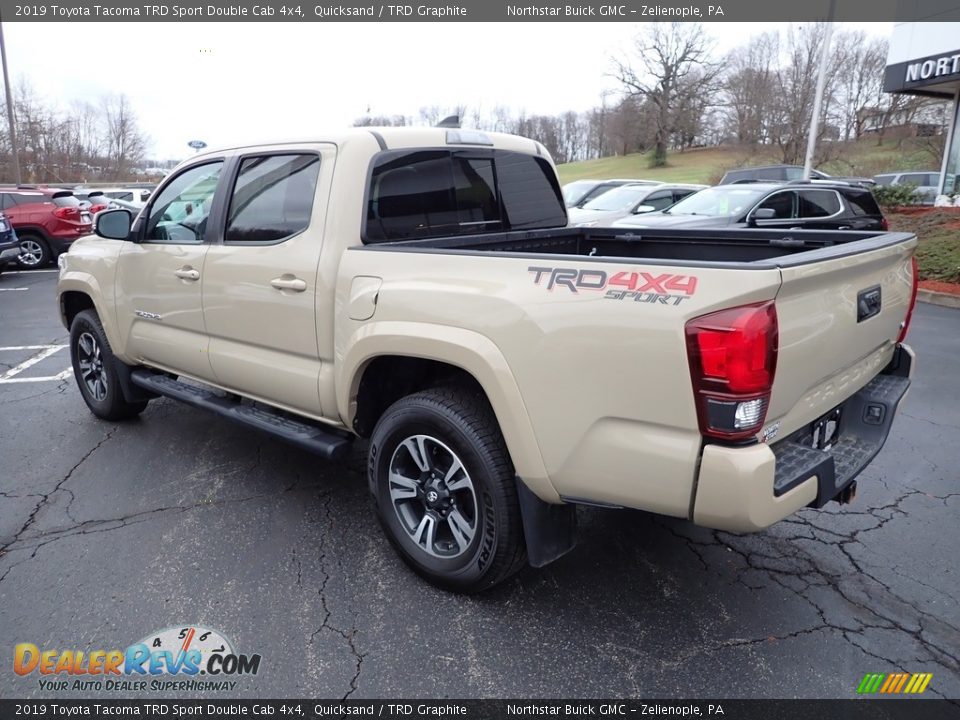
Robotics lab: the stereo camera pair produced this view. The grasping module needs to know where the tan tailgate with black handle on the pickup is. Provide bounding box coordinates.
[766,233,917,440]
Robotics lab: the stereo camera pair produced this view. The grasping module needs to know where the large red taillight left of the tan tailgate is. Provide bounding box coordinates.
[686,301,778,440]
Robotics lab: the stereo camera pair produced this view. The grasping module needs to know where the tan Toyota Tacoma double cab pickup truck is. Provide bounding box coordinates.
[59,128,917,591]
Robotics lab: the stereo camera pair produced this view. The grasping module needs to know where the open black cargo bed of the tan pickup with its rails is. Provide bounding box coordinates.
[364,228,912,269]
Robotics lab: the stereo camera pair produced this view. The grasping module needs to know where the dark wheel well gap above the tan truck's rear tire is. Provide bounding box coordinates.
[353,355,489,437]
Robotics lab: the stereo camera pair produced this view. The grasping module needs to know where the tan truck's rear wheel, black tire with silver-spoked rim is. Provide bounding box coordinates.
[368,388,526,593]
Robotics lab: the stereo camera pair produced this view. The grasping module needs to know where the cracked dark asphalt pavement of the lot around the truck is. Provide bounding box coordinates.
[0,273,960,698]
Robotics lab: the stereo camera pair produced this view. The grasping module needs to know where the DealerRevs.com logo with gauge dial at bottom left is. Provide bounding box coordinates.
[13,626,261,692]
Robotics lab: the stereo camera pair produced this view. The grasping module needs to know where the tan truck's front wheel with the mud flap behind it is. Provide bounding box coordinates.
[70,310,147,420]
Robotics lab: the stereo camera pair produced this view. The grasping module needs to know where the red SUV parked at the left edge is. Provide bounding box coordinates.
[0,185,93,268]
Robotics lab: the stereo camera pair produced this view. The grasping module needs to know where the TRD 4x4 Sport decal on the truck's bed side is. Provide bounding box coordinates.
[527,265,697,305]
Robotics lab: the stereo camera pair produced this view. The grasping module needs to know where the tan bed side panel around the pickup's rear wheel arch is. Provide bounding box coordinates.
[335,248,780,517]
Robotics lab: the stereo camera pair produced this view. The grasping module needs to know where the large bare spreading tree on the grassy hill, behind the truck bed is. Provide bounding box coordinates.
[614,22,720,167]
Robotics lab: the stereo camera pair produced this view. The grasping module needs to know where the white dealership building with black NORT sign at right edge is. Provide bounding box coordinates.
[883,22,960,204]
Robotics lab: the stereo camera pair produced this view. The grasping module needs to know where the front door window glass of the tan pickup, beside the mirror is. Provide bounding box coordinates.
[144,162,223,243]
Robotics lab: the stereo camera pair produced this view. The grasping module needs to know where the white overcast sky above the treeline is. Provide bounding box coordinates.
[3,22,892,159]
